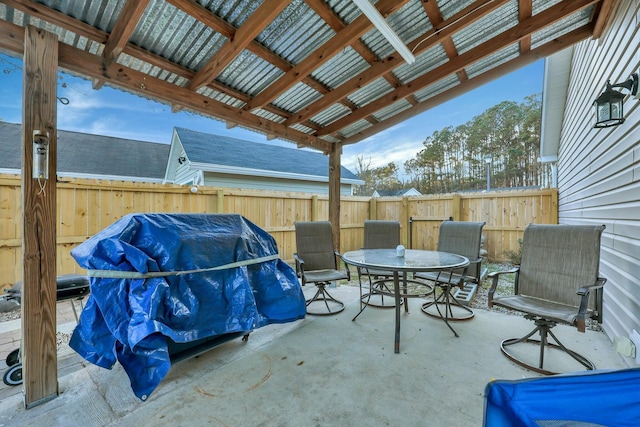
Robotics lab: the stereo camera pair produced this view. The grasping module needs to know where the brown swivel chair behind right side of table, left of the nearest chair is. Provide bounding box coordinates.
[416,221,485,337]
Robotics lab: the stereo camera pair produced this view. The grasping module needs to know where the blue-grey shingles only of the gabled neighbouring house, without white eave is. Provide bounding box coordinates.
[175,127,360,180]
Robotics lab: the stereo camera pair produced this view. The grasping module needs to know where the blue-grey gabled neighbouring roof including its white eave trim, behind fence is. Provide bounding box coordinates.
[166,128,364,185]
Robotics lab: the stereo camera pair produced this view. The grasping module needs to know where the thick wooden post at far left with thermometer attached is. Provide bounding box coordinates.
[21,26,58,408]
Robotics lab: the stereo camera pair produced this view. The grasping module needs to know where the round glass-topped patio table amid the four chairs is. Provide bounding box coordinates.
[342,249,469,353]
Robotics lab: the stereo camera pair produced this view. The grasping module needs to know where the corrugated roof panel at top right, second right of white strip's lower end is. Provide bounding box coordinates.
[452,0,518,55]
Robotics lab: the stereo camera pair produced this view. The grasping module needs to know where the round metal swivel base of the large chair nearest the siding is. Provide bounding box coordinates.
[500,315,596,375]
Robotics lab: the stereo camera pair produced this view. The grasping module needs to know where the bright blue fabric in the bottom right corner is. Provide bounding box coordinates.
[484,369,640,427]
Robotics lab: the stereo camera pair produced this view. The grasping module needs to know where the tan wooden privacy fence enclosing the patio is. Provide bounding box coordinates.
[0,175,558,289]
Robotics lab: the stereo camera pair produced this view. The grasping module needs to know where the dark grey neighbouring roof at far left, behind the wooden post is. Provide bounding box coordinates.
[0,122,170,182]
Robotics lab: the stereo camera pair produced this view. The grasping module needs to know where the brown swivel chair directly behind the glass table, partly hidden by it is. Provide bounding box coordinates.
[358,220,400,308]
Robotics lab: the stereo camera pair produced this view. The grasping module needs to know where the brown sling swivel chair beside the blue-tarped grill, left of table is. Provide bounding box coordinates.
[293,221,351,315]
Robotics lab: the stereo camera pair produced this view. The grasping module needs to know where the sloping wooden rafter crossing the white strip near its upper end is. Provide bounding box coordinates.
[245,0,408,111]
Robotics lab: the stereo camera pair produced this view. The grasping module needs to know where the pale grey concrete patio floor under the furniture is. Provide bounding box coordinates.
[0,285,628,427]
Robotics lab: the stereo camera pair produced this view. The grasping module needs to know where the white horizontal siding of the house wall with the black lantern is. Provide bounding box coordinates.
[558,0,640,339]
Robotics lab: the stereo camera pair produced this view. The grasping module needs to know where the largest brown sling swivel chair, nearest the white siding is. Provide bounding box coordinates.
[487,224,606,375]
